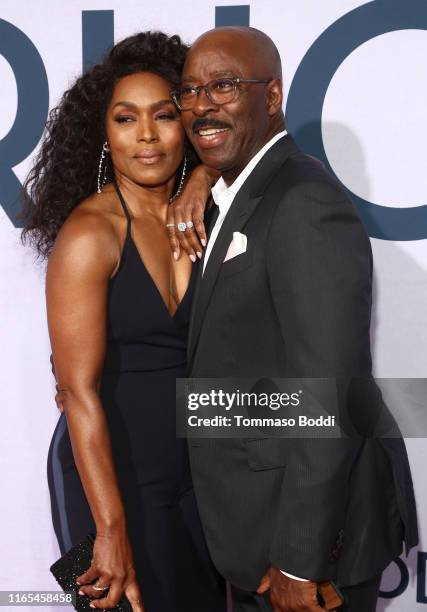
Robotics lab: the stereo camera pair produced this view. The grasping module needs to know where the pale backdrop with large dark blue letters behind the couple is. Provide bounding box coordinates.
[0,0,427,612]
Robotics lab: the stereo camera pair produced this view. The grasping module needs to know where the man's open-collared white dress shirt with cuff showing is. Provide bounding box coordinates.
[203,130,307,582]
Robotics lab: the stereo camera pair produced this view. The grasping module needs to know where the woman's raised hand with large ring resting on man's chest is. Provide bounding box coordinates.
[167,164,219,263]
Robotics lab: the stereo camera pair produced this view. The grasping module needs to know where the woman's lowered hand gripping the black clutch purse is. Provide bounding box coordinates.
[77,528,144,612]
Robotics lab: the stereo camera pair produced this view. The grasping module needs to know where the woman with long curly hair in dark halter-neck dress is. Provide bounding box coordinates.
[24,32,225,612]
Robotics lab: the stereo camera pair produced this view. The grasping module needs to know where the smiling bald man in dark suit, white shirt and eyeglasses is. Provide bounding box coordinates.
[170,27,417,612]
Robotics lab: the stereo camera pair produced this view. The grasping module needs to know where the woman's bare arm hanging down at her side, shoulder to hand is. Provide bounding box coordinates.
[46,212,143,612]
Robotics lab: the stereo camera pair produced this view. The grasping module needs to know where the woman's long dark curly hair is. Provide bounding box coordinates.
[22,32,188,258]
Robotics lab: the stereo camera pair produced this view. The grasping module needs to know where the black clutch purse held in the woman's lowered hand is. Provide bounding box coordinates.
[50,533,132,612]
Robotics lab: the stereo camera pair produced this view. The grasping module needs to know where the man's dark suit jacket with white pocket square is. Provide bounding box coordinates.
[188,135,417,590]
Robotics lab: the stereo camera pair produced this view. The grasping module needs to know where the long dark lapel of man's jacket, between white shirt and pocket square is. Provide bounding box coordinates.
[188,135,298,364]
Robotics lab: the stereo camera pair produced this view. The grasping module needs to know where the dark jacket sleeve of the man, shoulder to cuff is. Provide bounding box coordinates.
[267,178,372,581]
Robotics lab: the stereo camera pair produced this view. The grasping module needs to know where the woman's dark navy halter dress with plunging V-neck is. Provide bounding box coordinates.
[48,186,225,612]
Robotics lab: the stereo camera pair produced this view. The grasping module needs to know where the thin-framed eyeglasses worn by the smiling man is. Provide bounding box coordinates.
[170,77,272,110]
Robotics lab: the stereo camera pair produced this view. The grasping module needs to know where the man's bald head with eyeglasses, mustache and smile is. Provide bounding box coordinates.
[182,26,285,184]
